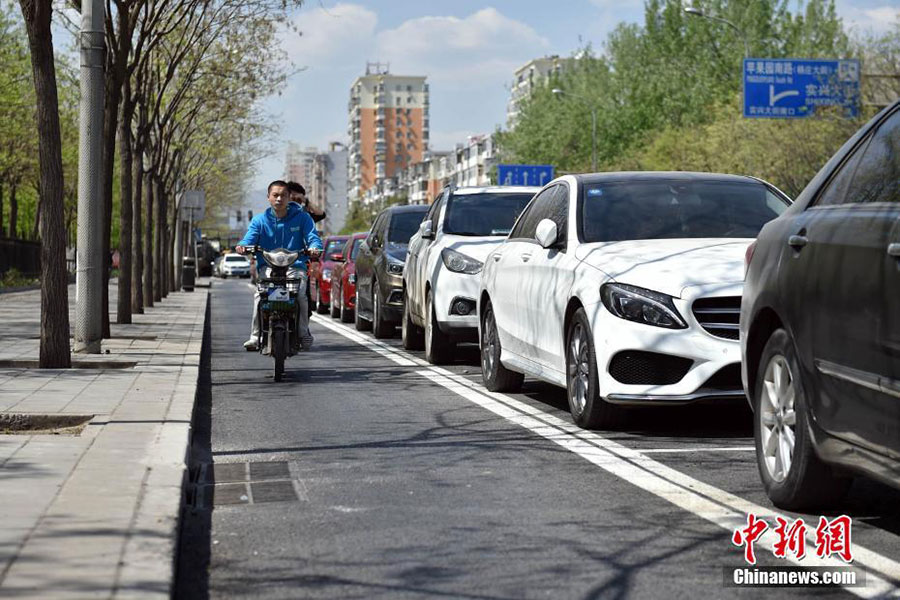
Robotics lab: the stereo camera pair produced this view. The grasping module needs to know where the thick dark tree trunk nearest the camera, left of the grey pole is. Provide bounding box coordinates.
[20,0,72,369]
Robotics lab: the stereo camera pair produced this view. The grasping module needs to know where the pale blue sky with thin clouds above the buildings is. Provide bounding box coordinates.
[250,0,900,189]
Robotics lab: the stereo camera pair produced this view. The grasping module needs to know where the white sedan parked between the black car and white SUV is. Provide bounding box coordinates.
[478,173,790,428]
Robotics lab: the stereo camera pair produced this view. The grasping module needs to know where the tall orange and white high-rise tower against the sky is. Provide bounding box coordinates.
[347,63,429,201]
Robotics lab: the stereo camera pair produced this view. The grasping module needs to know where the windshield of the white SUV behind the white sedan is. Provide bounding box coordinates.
[444,193,534,236]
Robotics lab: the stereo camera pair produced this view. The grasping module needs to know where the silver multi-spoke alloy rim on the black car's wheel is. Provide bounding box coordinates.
[757,354,797,482]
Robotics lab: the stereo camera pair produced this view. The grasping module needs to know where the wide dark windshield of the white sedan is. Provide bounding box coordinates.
[579,180,788,242]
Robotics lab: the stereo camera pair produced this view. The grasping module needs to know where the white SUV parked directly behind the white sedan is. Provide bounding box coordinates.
[401,186,541,364]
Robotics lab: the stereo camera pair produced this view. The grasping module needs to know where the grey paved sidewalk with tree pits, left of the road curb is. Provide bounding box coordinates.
[0,282,208,598]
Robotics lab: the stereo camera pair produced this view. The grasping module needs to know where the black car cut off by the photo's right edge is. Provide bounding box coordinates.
[740,102,900,510]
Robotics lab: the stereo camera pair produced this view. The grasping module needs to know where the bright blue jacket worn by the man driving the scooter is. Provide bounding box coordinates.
[237,202,322,271]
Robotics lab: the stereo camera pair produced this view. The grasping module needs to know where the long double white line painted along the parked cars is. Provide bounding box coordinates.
[310,314,900,598]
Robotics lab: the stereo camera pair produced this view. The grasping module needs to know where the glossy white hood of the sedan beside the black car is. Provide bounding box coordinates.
[575,238,753,298]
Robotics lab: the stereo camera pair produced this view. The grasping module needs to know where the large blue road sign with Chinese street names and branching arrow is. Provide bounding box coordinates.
[744,58,859,119]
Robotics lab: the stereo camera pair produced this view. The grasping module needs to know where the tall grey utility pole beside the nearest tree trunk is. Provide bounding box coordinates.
[75,0,109,354]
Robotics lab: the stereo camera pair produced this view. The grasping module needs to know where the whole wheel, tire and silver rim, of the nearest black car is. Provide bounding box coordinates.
[753,329,852,511]
